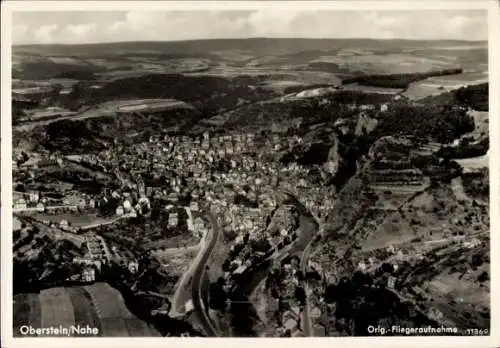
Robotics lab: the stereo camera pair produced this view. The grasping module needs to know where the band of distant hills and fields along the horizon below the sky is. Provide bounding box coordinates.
[12,38,488,82]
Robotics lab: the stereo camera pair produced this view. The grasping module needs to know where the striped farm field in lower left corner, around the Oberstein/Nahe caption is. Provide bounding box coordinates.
[14,283,161,337]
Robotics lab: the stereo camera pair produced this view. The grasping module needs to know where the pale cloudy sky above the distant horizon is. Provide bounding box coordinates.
[12,9,488,45]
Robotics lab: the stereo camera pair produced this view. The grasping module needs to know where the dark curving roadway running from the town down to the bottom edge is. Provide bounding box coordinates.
[191,212,220,337]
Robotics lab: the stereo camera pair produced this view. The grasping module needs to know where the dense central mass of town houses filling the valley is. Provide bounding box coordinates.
[62,133,320,235]
